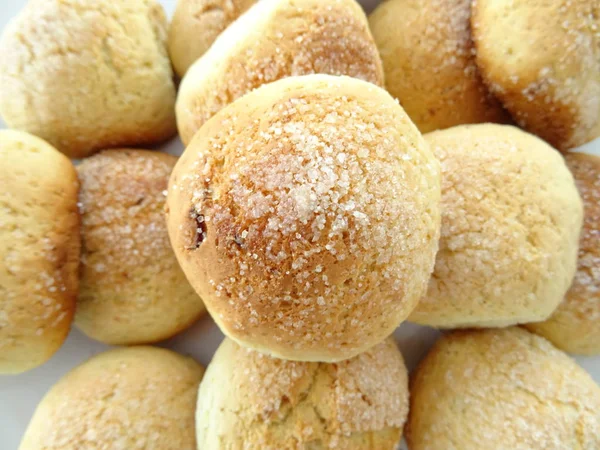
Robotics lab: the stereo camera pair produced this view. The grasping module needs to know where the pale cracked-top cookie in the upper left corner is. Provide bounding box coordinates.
[0,0,175,158]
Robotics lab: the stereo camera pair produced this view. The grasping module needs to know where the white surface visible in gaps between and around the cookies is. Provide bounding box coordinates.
[0,0,600,450]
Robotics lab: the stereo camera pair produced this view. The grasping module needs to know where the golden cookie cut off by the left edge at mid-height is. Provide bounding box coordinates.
[0,130,80,374]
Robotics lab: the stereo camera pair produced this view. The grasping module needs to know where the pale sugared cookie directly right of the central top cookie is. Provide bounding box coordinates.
[409,124,583,328]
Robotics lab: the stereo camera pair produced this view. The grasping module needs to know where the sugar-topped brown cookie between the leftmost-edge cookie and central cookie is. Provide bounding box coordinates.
[75,150,204,345]
